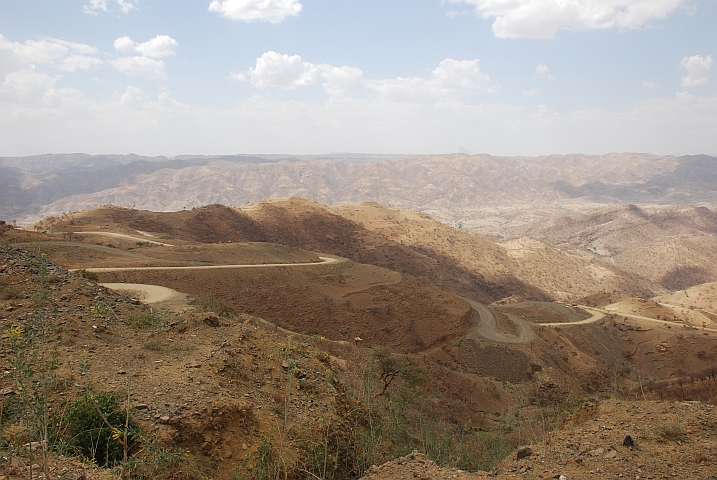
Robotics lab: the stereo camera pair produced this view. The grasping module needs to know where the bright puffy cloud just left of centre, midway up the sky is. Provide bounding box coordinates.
[241,51,321,90]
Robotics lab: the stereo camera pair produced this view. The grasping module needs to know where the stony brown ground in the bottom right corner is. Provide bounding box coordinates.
[364,400,717,480]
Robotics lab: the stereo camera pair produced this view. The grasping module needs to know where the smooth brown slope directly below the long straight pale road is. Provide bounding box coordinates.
[100,262,470,352]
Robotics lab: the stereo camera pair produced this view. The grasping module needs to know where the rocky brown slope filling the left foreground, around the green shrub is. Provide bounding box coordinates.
[0,245,347,478]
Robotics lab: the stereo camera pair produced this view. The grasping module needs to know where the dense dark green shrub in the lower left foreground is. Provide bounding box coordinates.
[65,391,136,467]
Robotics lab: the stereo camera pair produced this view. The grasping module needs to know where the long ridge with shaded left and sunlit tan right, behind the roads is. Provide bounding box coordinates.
[50,198,662,303]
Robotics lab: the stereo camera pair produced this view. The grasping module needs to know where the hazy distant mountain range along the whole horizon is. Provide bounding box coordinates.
[0,153,717,232]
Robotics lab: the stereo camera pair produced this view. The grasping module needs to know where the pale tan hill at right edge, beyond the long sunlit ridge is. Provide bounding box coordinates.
[519,205,717,290]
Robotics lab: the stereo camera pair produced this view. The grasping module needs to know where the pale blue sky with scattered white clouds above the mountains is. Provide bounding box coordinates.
[0,0,717,156]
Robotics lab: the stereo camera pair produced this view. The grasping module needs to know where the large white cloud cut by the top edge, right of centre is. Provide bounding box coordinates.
[447,0,687,38]
